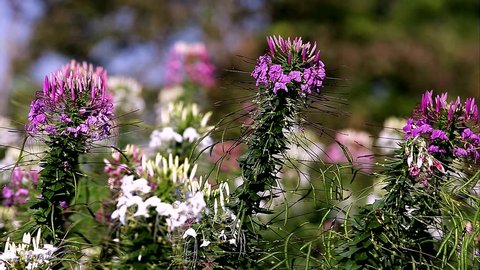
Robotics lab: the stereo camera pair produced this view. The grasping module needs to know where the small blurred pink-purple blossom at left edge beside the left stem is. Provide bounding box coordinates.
[2,167,38,207]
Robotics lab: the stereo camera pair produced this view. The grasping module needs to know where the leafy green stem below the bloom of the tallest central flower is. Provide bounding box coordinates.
[237,91,299,232]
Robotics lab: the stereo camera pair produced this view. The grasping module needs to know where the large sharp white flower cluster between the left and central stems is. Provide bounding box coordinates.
[112,155,206,231]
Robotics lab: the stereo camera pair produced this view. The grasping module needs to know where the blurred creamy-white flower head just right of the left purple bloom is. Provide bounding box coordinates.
[108,77,145,112]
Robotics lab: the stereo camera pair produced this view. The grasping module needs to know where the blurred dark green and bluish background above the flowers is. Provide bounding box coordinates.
[0,0,480,133]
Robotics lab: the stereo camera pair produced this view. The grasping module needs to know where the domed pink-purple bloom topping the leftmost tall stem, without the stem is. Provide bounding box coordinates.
[26,60,114,140]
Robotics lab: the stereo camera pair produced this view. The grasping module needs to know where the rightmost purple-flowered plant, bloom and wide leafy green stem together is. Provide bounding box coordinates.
[338,91,480,269]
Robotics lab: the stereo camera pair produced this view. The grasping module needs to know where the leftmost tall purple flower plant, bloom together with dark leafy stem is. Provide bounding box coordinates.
[26,61,114,241]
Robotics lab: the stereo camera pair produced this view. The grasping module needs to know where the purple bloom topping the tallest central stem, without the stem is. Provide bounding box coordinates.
[251,36,326,96]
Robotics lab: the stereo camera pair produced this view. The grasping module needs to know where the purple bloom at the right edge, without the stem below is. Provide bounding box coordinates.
[403,91,480,162]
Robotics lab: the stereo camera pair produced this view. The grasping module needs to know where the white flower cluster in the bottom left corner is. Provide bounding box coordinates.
[0,230,57,270]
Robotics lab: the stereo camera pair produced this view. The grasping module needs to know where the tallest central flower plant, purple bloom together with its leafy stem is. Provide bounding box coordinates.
[236,36,326,232]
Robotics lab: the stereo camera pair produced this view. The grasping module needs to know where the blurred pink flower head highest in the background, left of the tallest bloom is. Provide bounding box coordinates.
[165,42,215,88]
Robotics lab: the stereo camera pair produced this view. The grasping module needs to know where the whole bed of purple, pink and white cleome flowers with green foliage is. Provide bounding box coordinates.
[0,36,480,270]
